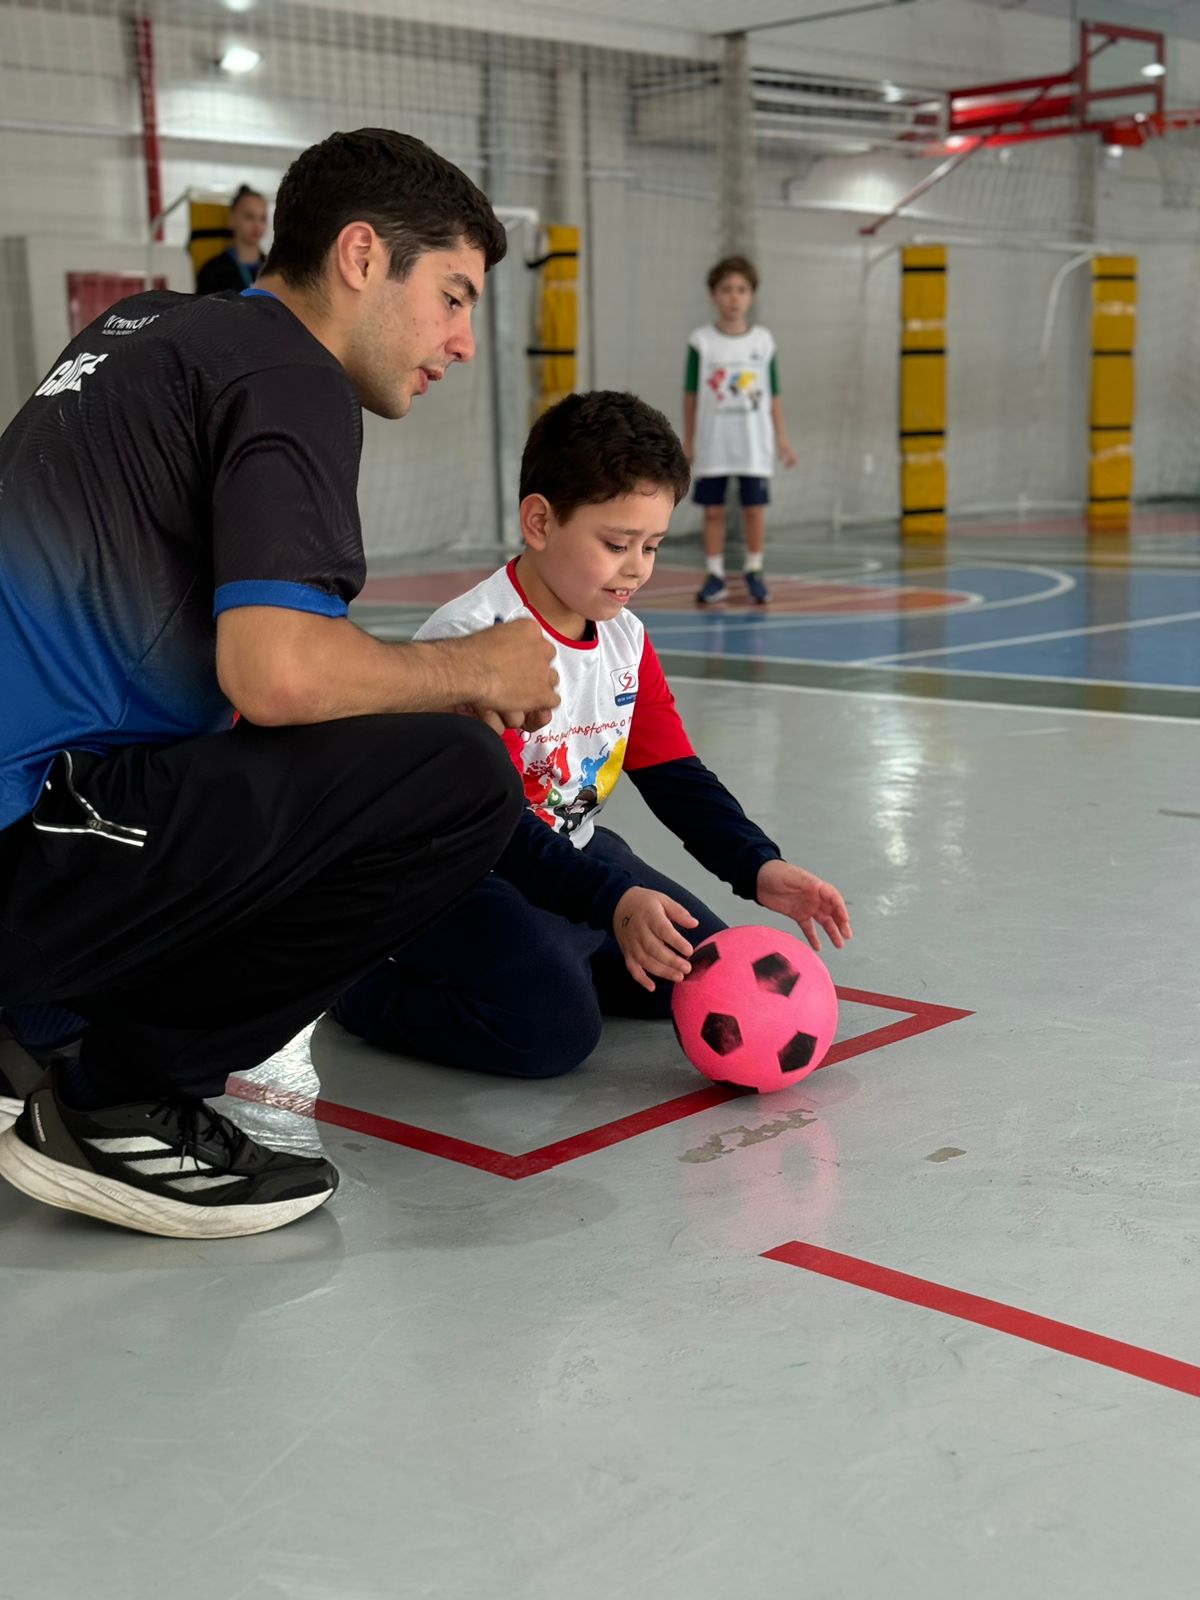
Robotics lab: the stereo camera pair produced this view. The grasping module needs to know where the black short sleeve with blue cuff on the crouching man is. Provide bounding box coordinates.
[206,365,366,616]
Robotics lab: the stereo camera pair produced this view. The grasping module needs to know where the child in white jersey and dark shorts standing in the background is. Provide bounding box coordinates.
[683,256,795,605]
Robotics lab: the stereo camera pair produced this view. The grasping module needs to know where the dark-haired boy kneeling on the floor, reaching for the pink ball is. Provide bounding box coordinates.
[334,392,850,1078]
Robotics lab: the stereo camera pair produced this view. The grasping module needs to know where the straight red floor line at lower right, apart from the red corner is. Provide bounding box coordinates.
[763,1238,1200,1397]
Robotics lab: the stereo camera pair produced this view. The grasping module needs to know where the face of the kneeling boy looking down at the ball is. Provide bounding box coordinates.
[522,483,675,622]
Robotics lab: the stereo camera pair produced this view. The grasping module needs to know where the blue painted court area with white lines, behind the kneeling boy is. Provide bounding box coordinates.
[638,562,1200,688]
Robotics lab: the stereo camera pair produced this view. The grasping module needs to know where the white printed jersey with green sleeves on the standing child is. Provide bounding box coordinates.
[686,323,778,478]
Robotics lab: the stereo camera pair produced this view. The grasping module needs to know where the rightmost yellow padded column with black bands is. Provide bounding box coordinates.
[1088,256,1138,533]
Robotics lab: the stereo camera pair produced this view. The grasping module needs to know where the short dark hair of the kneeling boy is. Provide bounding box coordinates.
[520,389,691,522]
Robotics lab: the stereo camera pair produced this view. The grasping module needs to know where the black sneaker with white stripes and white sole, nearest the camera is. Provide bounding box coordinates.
[0,1072,338,1238]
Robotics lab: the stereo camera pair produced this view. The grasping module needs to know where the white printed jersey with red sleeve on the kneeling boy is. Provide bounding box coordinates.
[416,560,696,845]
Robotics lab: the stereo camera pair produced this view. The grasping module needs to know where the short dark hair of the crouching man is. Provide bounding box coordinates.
[262,128,509,288]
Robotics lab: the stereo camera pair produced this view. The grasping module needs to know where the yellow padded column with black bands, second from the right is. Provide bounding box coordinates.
[899,245,946,539]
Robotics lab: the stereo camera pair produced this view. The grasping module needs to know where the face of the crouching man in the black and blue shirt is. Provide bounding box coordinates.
[342,240,485,418]
